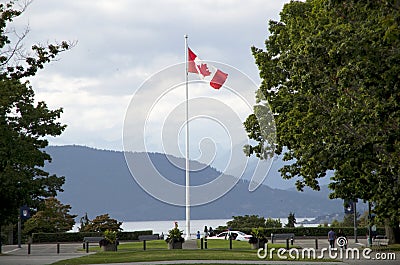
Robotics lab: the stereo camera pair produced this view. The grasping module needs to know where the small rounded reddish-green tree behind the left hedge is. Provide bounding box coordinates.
[24,197,77,235]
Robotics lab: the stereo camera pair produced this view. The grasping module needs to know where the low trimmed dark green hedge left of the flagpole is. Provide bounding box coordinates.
[32,230,153,243]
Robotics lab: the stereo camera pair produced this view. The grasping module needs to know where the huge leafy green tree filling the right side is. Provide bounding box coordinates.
[245,0,400,243]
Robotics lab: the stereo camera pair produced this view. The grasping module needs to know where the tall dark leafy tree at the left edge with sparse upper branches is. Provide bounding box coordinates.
[0,2,70,227]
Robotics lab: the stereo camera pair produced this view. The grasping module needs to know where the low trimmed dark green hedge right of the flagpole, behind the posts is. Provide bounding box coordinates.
[215,227,385,237]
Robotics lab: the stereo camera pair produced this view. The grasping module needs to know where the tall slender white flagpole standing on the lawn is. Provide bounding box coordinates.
[185,35,190,240]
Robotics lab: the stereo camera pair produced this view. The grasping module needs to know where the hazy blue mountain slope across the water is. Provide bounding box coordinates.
[45,146,342,221]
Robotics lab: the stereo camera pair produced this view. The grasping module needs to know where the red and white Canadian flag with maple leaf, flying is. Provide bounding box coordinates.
[188,48,228,89]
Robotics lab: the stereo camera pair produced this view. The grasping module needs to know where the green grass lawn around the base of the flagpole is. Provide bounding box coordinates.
[54,240,330,265]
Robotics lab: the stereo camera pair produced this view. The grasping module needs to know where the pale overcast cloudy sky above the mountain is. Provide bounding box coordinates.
[7,0,296,187]
